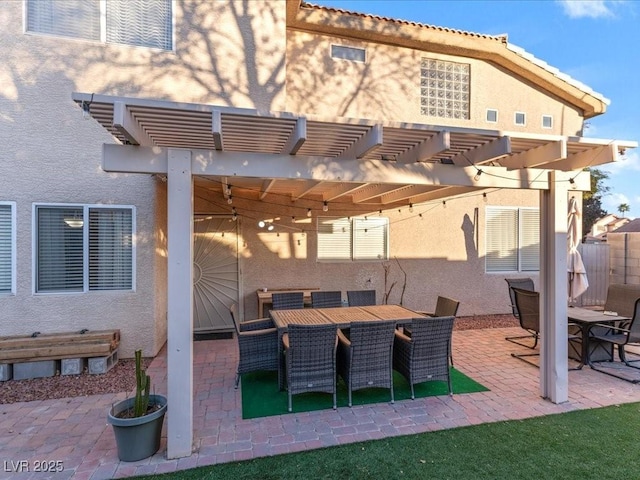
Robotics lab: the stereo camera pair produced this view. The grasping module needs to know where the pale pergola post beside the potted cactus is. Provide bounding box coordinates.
[167,149,193,458]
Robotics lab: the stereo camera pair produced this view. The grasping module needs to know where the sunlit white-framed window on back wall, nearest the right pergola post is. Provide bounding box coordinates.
[485,207,540,272]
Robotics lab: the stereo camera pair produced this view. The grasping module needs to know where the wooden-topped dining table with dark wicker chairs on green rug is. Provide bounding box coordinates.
[231,290,459,411]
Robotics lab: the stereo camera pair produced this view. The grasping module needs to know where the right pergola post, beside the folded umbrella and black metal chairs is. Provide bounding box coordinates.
[540,171,569,403]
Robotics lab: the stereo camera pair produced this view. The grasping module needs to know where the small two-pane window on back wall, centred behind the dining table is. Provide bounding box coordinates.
[318,217,389,262]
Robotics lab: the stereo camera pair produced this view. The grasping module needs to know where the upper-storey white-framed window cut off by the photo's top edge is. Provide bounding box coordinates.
[25,0,173,50]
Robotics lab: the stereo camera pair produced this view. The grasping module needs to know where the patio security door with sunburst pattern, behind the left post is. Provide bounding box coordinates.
[193,215,239,333]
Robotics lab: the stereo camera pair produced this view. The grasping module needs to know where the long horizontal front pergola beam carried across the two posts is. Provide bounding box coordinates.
[103,144,591,191]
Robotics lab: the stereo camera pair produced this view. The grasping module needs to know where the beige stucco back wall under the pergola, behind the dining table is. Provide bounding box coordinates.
[196,189,539,319]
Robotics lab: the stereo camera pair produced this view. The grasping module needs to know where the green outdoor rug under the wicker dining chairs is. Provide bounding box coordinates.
[241,367,489,419]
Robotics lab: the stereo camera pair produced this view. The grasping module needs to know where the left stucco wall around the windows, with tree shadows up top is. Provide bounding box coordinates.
[0,1,286,357]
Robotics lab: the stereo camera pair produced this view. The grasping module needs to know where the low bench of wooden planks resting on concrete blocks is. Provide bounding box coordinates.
[0,330,120,381]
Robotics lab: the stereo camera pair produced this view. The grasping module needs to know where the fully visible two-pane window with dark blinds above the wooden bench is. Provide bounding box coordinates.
[33,205,135,293]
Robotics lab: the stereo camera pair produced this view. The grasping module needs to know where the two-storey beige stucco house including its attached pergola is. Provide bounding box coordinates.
[0,0,636,457]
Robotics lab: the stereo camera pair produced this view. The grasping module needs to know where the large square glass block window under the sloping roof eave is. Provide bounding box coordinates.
[420,58,471,120]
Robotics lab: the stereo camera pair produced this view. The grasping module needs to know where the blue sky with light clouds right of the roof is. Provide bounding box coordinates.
[308,0,640,218]
